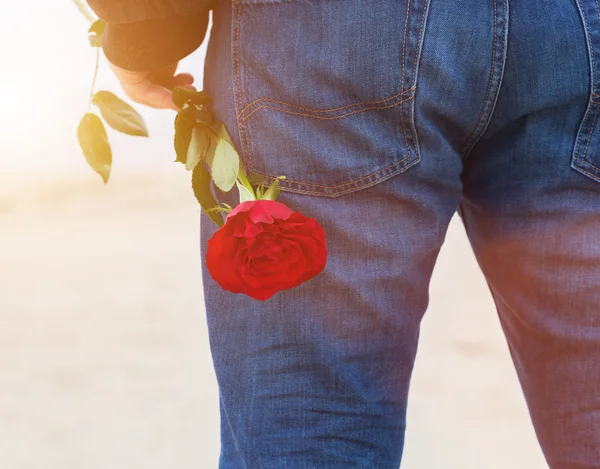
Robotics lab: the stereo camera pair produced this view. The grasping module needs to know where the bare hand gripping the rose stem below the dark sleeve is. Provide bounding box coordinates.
[110,64,194,111]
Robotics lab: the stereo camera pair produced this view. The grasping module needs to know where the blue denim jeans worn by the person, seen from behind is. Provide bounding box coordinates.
[201,0,600,469]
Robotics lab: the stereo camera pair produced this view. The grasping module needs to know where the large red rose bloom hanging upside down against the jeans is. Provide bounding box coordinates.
[206,200,327,300]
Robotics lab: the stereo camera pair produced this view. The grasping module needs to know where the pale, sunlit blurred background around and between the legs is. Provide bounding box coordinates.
[0,0,547,469]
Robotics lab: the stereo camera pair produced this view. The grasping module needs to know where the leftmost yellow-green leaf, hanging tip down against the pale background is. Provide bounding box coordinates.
[77,112,112,184]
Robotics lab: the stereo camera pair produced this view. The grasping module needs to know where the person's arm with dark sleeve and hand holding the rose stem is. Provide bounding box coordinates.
[88,0,214,110]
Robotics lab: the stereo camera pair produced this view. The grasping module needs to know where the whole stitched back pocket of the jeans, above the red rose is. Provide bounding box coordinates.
[232,0,429,197]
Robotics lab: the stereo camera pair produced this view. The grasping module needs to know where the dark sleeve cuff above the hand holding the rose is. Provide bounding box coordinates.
[88,0,214,71]
